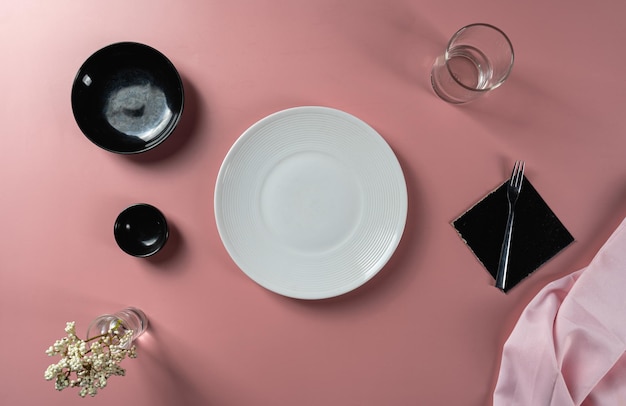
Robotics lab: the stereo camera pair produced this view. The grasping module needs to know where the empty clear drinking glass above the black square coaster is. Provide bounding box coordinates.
[430,23,514,104]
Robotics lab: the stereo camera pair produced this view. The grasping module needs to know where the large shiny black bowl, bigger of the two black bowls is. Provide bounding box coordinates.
[72,42,184,154]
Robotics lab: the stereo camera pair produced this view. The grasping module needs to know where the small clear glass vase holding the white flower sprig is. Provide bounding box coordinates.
[87,307,148,348]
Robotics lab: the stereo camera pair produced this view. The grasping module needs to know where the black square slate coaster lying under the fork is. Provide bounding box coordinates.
[452,177,574,292]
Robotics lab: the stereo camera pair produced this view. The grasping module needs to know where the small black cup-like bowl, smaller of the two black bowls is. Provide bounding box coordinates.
[113,203,169,257]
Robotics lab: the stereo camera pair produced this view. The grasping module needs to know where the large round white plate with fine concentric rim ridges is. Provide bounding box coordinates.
[215,107,407,299]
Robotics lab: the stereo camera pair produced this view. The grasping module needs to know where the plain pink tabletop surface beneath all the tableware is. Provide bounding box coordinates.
[0,0,626,405]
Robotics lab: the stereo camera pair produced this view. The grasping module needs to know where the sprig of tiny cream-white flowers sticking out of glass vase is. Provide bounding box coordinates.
[44,320,137,397]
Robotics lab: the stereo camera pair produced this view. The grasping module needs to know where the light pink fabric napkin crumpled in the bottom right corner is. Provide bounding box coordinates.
[494,220,626,406]
